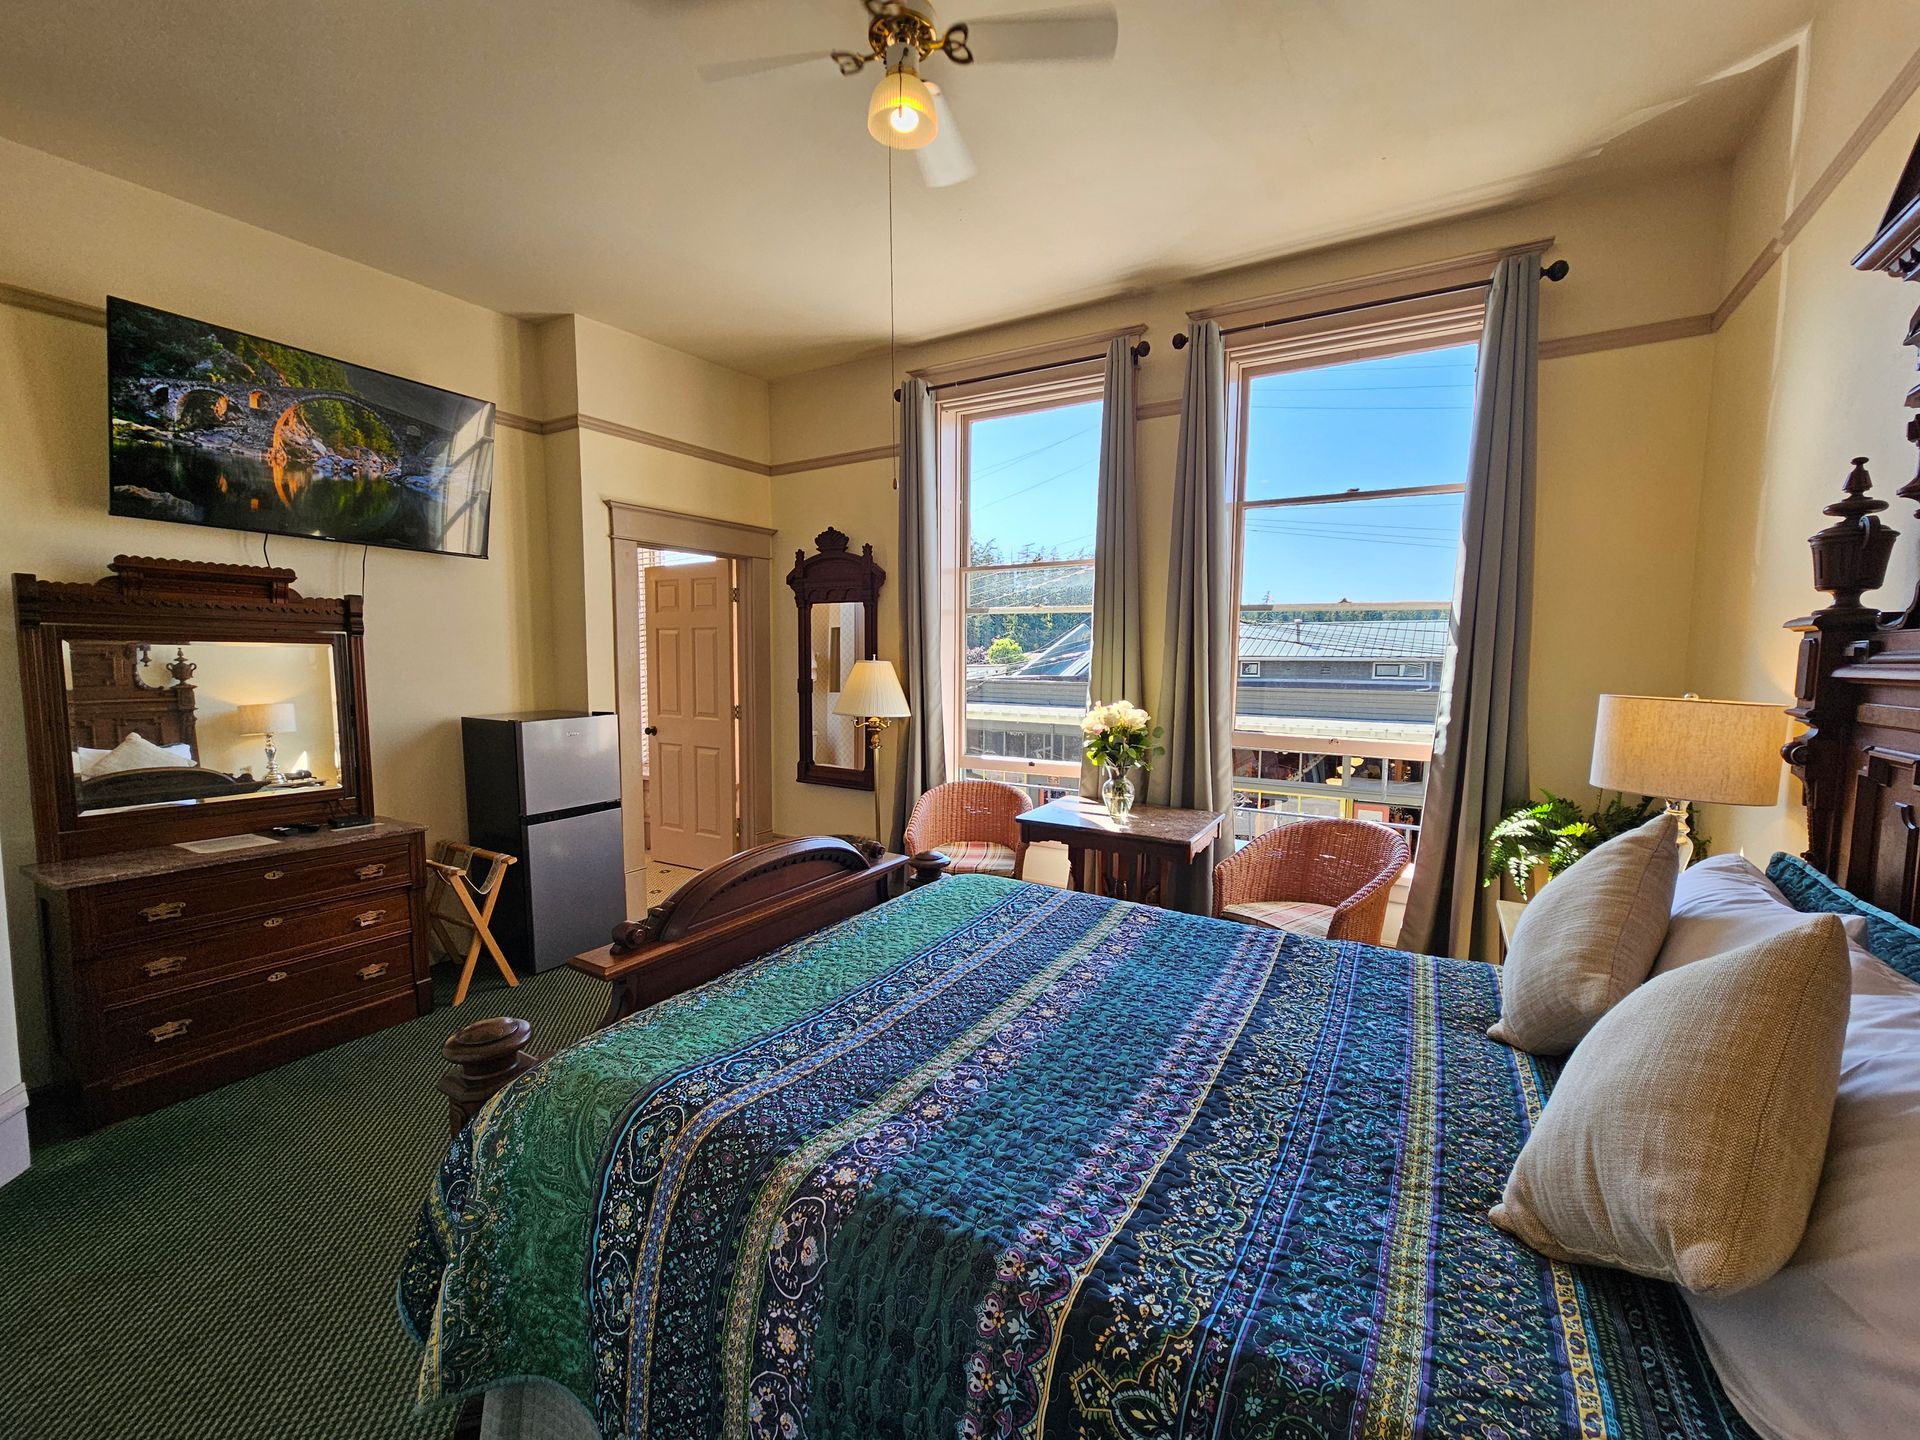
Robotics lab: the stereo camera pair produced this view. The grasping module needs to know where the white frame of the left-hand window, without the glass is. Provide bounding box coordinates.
[935,357,1106,781]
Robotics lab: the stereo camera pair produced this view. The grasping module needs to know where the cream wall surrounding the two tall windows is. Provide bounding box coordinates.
[772,165,1730,833]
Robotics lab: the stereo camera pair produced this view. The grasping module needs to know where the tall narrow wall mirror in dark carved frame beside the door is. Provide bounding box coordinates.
[787,528,887,789]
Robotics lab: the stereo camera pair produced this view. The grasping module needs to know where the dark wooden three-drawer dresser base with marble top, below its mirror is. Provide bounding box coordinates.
[27,820,434,1123]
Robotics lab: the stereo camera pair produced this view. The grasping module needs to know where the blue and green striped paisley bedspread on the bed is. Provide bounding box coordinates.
[399,876,1751,1440]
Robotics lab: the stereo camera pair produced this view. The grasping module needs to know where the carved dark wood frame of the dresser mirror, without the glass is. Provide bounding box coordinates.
[13,555,372,862]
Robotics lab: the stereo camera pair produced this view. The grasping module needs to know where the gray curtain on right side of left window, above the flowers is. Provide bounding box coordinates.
[1081,336,1146,797]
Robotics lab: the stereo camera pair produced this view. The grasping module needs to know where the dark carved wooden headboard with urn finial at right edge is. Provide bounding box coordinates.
[1784,135,1920,922]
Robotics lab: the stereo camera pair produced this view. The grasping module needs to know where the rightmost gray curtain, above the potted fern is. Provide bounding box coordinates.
[1400,255,1540,958]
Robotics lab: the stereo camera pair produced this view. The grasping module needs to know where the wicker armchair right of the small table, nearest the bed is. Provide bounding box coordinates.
[1213,820,1407,945]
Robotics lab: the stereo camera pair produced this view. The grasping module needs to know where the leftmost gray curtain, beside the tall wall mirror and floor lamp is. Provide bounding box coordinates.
[889,380,947,849]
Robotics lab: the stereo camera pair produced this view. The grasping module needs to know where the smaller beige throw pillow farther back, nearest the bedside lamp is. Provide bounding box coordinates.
[1486,814,1680,1054]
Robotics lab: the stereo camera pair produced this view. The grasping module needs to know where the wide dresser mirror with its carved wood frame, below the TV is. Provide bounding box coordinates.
[13,557,372,860]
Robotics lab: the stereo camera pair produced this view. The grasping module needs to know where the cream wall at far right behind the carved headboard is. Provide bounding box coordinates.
[1688,67,1920,862]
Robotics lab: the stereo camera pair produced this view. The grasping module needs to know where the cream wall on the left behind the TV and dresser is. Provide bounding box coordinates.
[0,140,772,1110]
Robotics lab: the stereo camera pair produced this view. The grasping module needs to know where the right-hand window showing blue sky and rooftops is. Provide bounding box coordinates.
[1233,332,1478,856]
